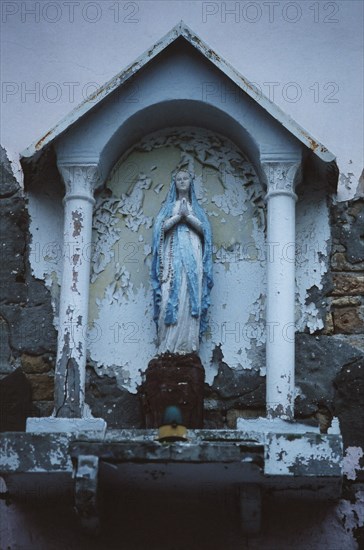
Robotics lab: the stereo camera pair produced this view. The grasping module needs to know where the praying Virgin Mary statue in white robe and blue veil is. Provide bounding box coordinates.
[151,170,213,354]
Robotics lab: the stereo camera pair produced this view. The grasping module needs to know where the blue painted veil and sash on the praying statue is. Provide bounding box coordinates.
[151,169,213,338]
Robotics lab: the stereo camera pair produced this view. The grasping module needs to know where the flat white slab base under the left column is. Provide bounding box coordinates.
[25,416,107,435]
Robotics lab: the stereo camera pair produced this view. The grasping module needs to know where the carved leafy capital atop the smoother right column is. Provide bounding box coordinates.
[262,160,302,200]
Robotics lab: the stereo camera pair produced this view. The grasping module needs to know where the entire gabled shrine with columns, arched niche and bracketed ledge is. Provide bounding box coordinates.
[13,22,344,538]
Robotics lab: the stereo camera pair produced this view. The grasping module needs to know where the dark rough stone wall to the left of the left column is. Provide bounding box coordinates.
[0,149,56,429]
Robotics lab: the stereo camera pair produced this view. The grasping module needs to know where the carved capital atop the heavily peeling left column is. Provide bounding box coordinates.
[58,162,102,208]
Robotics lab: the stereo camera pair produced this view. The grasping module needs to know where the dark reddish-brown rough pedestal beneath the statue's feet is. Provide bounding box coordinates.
[139,353,205,428]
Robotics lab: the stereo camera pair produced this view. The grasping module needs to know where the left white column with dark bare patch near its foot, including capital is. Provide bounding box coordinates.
[54,164,100,418]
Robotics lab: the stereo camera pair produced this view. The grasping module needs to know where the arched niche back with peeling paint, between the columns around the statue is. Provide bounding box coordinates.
[89,128,266,392]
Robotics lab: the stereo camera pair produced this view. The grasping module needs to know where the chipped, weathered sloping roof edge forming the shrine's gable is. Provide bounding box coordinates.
[21,21,335,162]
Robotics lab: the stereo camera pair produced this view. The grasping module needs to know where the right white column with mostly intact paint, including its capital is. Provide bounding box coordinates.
[263,161,300,419]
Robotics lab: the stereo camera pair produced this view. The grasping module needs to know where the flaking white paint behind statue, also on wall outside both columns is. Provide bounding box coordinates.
[24,128,336,406]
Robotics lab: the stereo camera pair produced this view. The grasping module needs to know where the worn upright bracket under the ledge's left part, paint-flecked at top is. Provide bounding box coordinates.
[74,455,100,534]
